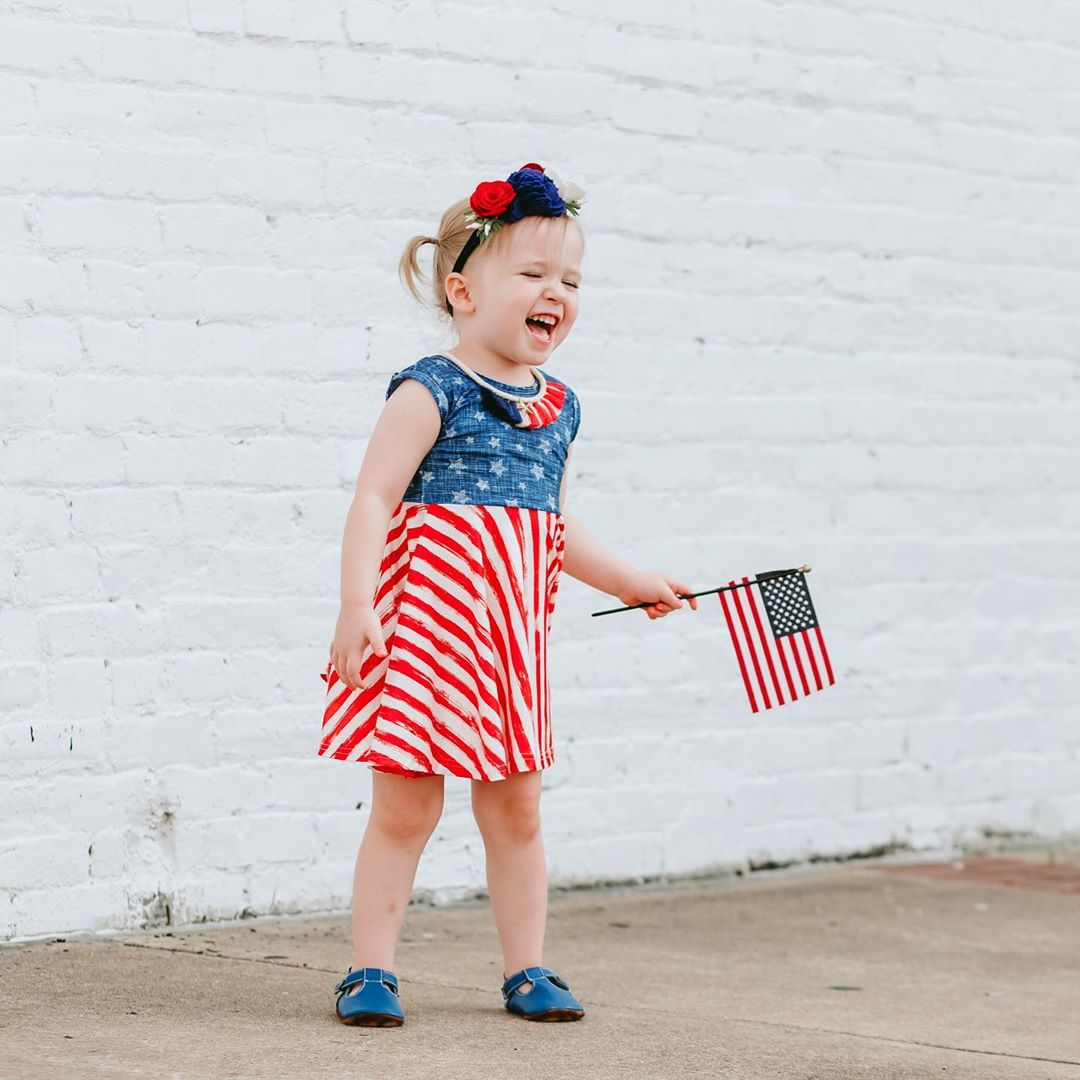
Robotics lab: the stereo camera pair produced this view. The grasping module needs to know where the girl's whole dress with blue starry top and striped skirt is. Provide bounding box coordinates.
[319,354,581,781]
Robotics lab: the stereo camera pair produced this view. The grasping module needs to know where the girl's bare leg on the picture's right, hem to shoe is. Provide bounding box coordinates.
[472,770,548,993]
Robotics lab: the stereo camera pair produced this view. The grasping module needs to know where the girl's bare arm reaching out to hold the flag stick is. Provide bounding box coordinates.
[558,443,698,619]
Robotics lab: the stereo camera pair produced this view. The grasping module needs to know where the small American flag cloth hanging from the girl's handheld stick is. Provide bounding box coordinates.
[717,570,836,713]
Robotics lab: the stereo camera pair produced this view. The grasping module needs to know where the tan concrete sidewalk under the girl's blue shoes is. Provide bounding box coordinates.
[0,854,1080,1080]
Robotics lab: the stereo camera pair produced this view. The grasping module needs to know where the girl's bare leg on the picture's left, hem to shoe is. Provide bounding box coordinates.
[352,769,443,971]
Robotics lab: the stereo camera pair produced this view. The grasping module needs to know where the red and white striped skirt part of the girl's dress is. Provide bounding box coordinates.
[319,502,565,780]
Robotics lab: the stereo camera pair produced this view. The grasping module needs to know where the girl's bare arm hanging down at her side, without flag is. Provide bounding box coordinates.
[330,379,442,689]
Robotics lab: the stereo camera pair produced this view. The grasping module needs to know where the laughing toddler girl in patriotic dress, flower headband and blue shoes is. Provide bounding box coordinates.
[319,163,697,1027]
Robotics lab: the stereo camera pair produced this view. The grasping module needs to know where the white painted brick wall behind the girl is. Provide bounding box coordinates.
[0,0,1080,937]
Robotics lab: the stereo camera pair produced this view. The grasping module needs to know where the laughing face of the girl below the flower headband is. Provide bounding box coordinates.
[451,216,584,365]
